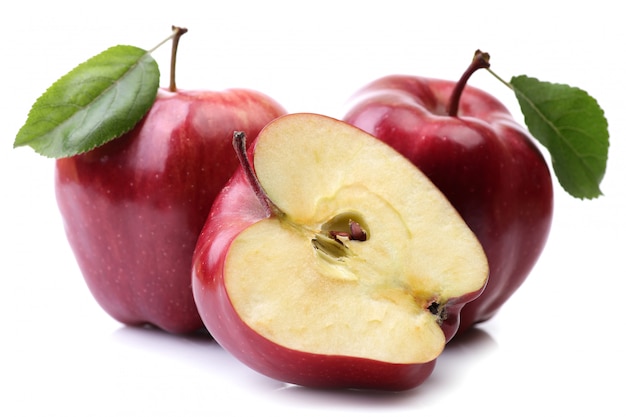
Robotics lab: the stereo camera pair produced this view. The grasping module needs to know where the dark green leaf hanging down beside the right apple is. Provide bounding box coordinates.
[510,75,609,198]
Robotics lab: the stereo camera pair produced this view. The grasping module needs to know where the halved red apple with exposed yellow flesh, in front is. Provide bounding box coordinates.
[192,114,488,390]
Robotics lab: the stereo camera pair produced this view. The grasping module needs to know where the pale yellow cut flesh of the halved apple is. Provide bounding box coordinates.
[225,114,488,363]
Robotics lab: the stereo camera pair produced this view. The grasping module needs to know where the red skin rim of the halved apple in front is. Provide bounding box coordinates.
[192,141,480,391]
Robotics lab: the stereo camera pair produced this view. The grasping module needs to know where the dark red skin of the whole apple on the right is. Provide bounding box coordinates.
[344,75,553,333]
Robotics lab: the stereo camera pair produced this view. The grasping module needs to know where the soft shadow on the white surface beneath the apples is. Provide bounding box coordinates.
[111,318,497,404]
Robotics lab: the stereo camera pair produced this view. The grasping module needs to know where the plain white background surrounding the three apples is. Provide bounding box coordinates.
[0,0,626,416]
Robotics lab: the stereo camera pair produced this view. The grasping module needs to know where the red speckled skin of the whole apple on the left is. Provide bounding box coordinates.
[55,89,285,333]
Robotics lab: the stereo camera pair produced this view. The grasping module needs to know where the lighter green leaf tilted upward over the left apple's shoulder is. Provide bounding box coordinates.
[14,45,160,158]
